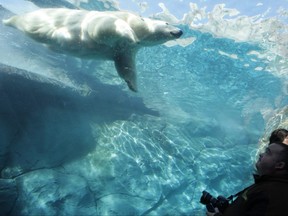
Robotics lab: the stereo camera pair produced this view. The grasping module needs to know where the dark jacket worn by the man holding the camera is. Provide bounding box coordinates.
[216,175,288,216]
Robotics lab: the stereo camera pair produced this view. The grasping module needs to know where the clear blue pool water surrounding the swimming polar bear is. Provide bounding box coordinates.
[0,0,288,216]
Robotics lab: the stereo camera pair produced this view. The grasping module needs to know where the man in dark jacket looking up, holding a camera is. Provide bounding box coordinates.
[206,142,288,216]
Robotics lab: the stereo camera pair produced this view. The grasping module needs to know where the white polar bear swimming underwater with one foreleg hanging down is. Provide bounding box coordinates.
[3,8,183,92]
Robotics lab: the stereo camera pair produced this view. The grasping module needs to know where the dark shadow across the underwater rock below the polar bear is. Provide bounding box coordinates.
[0,64,158,178]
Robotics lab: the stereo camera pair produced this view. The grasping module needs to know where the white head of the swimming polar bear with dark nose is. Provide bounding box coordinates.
[126,16,183,46]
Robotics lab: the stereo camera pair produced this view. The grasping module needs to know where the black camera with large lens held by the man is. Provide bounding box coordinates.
[200,191,229,213]
